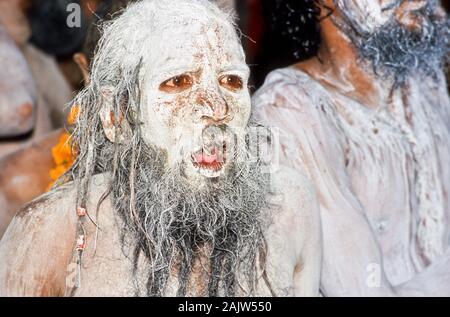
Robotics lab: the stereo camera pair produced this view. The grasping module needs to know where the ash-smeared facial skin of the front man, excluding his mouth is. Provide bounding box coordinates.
[135,18,250,179]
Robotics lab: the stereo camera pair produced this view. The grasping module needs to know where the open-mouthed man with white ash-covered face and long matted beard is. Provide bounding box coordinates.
[0,0,321,296]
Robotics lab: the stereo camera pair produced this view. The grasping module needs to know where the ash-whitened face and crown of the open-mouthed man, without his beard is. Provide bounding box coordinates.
[93,1,250,181]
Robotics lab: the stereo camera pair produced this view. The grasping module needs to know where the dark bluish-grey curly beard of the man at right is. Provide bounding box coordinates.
[335,2,450,85]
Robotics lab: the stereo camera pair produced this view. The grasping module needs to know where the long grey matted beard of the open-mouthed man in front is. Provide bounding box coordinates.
[112,132,271,296]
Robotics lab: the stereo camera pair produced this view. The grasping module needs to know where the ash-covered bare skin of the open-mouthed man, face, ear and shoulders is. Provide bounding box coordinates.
[0,1,321,296]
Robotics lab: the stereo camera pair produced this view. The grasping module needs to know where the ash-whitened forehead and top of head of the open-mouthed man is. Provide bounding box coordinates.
[85,0,245,86]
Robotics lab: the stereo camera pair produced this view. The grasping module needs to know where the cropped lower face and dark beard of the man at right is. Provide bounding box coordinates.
[335,0,450,85]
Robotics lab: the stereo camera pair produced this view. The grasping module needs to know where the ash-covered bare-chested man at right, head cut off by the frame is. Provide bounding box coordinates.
[254,0,450,296]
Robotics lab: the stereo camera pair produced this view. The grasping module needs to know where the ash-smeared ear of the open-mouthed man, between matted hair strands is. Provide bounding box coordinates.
[99,88,131,143]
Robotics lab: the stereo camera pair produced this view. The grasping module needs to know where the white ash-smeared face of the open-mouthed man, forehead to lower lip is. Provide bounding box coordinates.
[138,6,250,177]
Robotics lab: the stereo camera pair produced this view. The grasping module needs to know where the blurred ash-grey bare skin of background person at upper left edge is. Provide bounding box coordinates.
[0,23,37,139]
